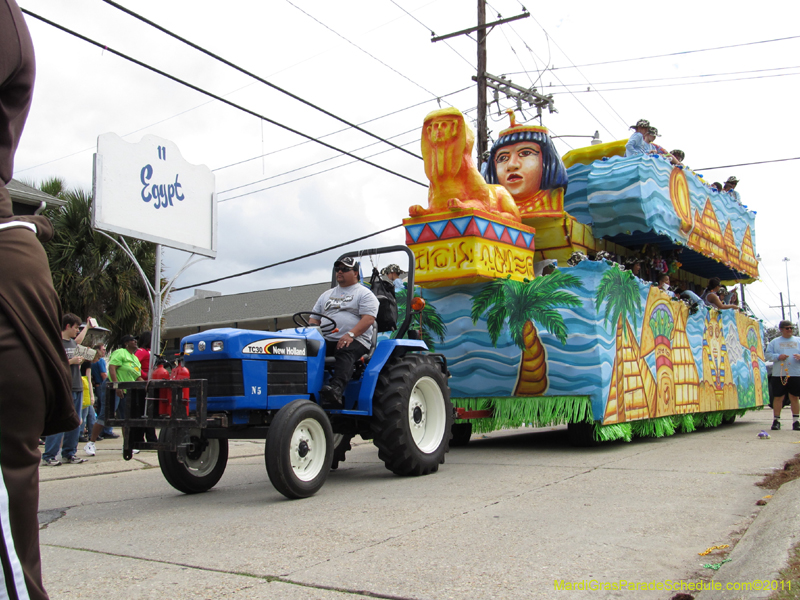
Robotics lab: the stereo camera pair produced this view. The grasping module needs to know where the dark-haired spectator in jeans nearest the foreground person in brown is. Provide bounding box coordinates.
[42,313,90,467]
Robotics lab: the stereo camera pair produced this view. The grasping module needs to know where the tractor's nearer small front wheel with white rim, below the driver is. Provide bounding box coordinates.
[264,400,333,500]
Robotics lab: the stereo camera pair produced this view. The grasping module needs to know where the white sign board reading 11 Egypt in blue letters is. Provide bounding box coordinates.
[92,133,217,258]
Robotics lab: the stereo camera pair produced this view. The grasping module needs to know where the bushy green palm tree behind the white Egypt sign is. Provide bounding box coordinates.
[39,178,160,343]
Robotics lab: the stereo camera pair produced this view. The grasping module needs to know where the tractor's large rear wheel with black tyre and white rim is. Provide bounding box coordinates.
[370,354,453,475]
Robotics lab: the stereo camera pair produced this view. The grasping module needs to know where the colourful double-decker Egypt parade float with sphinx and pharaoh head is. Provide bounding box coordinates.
[403,108,768,443]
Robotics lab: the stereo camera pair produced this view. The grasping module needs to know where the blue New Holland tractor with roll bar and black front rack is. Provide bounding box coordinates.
[107,246,454,498]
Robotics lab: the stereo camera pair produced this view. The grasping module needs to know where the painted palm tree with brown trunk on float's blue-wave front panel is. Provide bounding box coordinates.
[471,271,582,396]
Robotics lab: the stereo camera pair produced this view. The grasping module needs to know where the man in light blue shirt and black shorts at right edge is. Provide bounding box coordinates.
[764,321,800,431]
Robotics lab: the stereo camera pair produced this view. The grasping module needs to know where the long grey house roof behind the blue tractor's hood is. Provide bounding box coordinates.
[164,282,331,329]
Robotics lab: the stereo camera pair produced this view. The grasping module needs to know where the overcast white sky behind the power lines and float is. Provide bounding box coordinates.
[14,0,800,324]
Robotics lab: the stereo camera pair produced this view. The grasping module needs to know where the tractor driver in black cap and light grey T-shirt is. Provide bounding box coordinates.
[309,257,378,409]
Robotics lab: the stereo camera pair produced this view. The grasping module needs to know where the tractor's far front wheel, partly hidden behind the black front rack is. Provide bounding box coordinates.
[158,429,228,494]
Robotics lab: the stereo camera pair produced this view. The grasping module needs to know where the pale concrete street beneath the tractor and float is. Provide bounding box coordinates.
[39,410,800,600]
